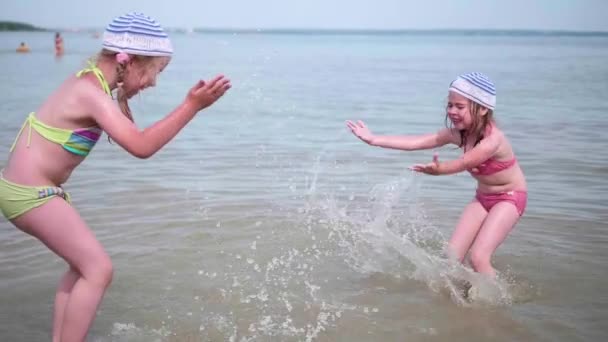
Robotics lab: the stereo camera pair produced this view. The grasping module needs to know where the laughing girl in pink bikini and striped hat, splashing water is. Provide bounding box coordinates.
[347,72,528,277]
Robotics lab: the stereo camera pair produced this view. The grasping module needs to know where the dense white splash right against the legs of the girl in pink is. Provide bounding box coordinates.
[296,150,513,306]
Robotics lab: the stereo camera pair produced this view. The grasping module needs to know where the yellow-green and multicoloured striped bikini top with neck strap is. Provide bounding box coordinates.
[11,63,112,156]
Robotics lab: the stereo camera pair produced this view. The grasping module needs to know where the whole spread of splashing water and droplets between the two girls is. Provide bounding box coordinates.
[142,151,528,341]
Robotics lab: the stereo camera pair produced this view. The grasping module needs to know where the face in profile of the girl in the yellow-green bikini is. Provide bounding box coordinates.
[123,57,171,98]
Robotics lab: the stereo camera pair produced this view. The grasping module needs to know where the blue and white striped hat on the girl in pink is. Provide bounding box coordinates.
[450,72,496,110]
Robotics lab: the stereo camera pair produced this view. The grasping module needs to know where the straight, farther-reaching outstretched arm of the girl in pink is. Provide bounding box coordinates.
[346,120,456,151]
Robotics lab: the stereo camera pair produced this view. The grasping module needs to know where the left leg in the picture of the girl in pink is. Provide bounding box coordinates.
[448,200,488,262]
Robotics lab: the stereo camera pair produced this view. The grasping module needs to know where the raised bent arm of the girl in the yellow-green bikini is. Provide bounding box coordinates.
[93,76,230,158]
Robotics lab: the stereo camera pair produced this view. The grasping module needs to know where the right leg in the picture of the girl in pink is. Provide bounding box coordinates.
[470,202,519,278]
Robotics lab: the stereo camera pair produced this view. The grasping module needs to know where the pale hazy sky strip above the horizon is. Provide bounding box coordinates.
[0,0,608,32]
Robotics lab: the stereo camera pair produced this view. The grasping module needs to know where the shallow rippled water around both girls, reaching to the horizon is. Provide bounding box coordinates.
[0,33,608,342]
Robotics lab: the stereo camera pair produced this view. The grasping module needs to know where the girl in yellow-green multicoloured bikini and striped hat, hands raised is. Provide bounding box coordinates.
[0,13,230,342]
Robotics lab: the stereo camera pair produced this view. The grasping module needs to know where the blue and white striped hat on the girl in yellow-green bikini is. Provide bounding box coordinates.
[103,12,173,56]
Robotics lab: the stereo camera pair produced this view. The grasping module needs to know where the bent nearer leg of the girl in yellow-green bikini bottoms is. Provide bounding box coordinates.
[13,198,112,342]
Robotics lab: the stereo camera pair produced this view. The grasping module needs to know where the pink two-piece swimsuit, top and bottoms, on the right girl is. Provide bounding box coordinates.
[468,158,528,216]
